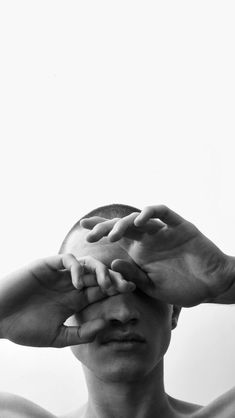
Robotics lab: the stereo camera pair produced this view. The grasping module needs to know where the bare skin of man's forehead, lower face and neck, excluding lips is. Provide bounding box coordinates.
[64,231,189,418]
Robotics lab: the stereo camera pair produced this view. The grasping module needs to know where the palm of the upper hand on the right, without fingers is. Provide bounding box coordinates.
[116,223,226,306]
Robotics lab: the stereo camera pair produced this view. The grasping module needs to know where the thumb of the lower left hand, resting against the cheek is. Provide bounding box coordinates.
[53,318,106,348]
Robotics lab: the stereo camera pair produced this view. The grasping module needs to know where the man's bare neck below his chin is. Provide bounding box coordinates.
[81,362,175,418]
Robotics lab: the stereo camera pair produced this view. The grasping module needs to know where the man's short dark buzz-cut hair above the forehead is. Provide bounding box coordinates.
[59,203,140,254]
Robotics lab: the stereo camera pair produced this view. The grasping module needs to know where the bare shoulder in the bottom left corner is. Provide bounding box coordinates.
[0,392,56,418]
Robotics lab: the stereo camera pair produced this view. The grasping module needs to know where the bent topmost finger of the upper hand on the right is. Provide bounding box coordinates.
[134,205,185,227]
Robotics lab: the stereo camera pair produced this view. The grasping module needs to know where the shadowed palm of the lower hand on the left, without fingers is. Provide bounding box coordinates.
[1,265,77,346]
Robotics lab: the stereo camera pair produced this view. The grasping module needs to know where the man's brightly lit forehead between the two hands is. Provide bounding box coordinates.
[66,228,132,266]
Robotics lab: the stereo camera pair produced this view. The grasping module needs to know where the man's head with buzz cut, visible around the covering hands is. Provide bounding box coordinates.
[60,205,179,381]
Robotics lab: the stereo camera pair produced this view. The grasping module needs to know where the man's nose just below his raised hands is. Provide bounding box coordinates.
[104,293,140,326]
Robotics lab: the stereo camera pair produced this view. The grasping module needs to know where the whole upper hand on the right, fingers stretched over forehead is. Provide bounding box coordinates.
[81,205,235,307]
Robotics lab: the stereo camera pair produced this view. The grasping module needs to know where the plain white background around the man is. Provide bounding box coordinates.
[0,0,235,414]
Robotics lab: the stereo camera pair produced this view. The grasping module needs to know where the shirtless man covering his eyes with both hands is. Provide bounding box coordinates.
[0,205,235,418]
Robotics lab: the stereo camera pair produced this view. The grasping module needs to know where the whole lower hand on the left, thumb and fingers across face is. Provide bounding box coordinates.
[0,254,135,347]
